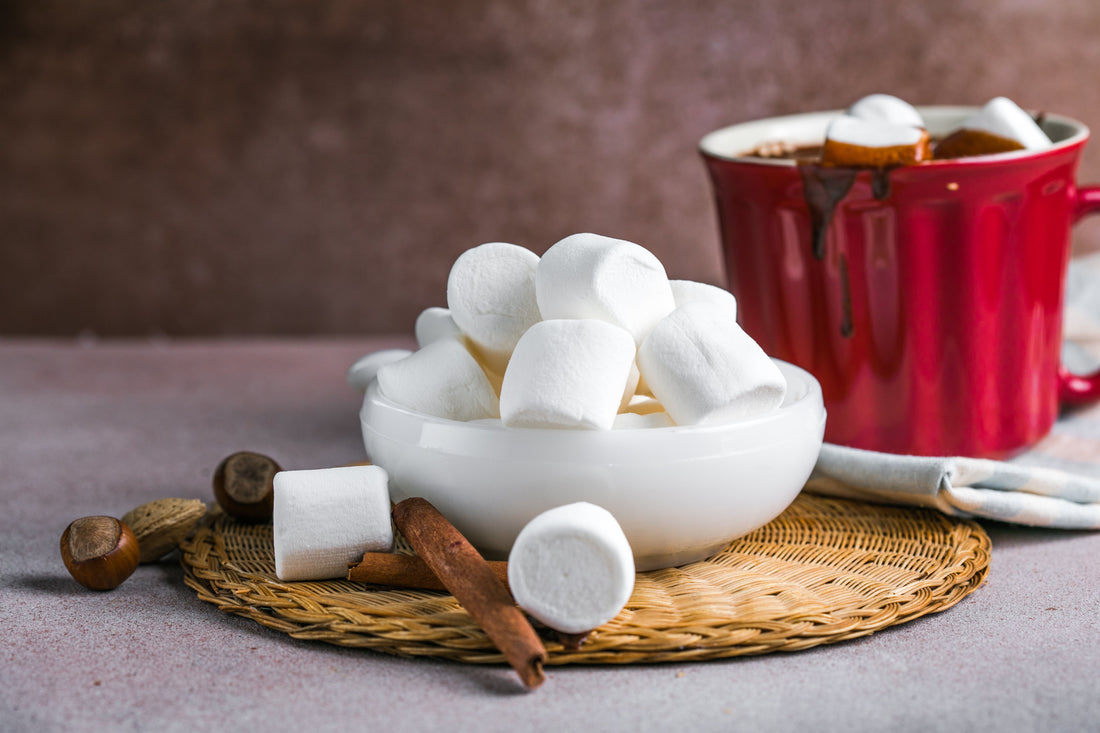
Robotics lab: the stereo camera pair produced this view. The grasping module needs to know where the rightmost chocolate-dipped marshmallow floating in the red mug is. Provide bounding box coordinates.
[936,97,1053,157]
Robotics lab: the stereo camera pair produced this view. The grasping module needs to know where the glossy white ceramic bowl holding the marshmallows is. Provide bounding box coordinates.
[360,360,825,570]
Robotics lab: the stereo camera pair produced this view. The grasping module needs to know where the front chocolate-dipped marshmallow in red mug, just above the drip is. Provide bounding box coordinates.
[822,114,932,167]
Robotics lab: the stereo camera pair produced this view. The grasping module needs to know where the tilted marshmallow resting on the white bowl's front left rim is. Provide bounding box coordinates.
[376,339,501,420]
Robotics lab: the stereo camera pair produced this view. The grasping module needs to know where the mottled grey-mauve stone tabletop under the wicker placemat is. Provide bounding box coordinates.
[0,338,1100,733]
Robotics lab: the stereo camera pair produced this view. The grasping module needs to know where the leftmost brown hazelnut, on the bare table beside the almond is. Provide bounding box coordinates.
[61,516,141,590]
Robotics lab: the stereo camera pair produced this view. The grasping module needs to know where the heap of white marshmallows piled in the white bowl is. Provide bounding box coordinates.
[348,233,787,430]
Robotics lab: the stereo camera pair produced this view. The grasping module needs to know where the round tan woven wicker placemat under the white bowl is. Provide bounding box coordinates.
[182,494,990,665]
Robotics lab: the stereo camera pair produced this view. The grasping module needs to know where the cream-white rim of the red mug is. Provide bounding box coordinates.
[699,105,1090,168]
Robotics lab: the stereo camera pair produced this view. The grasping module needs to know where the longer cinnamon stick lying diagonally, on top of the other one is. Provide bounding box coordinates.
[394,497,547,689]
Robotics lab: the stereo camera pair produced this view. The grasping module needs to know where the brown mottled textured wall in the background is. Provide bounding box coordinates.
[0,0,1100,336]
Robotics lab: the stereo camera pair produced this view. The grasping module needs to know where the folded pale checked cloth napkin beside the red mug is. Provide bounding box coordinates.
[806,254,1100,529]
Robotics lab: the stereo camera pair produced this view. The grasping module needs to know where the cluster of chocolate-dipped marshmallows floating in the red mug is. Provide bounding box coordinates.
[822,95,1052,167]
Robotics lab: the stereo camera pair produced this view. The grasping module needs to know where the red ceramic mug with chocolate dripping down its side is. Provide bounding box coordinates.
[701,107,1100,458]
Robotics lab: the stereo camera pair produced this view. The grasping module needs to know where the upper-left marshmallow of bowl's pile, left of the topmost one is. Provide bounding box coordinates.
[447,242,539,372]
